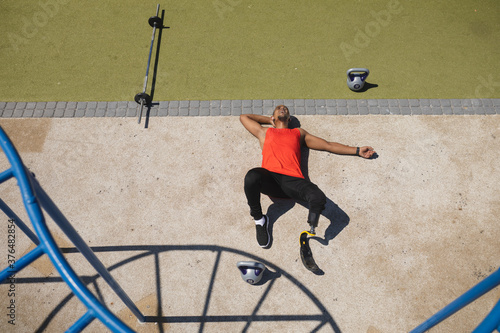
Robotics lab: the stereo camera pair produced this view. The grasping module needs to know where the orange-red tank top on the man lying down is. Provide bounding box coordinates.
[262,128,304,178]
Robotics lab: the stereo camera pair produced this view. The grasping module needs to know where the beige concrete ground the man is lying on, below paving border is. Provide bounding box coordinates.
[0,108,500,333]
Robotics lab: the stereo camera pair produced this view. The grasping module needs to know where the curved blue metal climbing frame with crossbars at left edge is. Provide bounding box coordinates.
[0,127,141,333]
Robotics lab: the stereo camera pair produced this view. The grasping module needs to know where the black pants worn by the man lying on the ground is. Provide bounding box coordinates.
[245,168,326,226]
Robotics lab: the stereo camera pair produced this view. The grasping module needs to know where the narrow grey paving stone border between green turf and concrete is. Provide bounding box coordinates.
[0,99,500,118]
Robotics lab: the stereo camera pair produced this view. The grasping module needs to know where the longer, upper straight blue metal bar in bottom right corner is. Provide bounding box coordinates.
[410,269,500,333]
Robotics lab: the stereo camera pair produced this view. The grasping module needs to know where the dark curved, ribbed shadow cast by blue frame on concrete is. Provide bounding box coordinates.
[16,245,341,332]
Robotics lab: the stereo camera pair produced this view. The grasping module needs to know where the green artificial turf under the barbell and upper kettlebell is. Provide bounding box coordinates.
[0,0,500,101]
